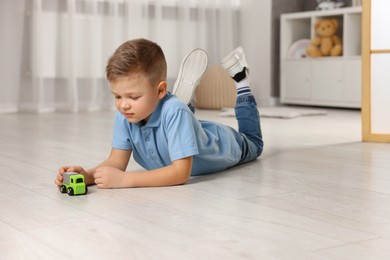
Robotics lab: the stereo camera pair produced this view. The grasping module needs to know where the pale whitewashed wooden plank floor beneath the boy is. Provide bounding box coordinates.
[0,106,390,260]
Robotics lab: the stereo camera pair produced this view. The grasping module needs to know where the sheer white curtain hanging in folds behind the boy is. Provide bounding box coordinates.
[0,0,240,113]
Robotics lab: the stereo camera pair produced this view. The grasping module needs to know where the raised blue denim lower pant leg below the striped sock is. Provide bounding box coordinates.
[235,95,264,164]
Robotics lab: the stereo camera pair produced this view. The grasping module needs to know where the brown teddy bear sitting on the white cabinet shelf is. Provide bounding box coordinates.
[306,19,343,57]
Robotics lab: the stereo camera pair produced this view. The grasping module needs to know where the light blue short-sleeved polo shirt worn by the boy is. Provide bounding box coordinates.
[112,93,241,175]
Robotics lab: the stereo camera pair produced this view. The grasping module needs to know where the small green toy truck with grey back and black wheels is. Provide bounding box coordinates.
[60,172,88,196]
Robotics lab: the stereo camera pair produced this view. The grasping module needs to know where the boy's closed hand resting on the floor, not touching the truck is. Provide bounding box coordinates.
[94,167,125,189]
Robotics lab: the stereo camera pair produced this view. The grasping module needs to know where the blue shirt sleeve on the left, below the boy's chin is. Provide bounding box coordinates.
[111,111,133,150]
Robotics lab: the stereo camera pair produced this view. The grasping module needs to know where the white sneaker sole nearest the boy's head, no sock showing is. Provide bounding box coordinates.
[172,49,208,104]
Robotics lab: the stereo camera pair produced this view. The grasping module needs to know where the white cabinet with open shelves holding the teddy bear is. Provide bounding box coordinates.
[280,7,362,108]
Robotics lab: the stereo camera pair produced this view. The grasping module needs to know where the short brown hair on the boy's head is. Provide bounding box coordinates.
[106,39,167,85]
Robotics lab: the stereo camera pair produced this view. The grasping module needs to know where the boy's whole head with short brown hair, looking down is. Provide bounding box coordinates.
[106,39,167,123]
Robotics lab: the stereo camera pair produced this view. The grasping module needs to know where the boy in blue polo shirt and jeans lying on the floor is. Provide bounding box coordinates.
[55,39,263,188]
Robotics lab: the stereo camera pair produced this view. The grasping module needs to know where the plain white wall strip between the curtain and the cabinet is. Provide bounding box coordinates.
[240,0,275,106]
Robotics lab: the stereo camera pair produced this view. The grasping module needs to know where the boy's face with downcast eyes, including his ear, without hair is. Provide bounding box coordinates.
[111,73,166,123]
